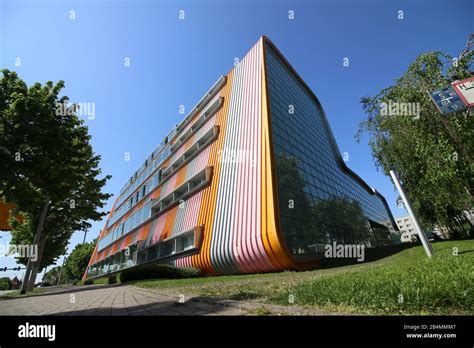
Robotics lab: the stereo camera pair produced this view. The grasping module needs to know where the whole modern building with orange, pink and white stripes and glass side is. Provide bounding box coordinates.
[84,37,399,278]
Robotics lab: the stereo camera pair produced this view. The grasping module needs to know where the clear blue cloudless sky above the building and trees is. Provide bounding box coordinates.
[0,0,474,276]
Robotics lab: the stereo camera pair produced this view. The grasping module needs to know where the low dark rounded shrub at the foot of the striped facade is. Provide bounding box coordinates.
[120,263,198,283]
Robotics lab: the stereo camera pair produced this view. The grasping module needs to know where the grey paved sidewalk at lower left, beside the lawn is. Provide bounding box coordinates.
[0,285,247,316]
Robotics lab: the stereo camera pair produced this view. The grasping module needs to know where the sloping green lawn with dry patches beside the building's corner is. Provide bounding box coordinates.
[133,240,474,314]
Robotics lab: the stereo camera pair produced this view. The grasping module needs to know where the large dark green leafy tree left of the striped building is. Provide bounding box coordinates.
[0,70,110,286]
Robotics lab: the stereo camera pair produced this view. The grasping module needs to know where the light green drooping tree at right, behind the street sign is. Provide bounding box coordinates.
[356,41,474,237]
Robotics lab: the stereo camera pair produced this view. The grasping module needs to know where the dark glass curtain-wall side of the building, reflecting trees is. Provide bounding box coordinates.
[266,44,397,259]
